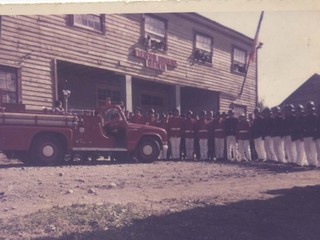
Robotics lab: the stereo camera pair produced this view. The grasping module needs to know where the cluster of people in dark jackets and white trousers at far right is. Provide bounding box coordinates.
[252,102,320,167]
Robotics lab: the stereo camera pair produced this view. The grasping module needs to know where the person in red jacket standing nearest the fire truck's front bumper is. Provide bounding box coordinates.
[168,109,183,159]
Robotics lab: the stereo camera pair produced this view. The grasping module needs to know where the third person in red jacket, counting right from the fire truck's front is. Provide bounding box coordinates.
[196,110,209,160]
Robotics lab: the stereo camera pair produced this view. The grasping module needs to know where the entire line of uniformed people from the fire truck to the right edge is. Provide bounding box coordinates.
[127,102,320,166]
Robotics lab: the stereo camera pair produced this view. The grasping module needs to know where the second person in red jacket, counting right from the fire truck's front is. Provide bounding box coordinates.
[183,110,195,160]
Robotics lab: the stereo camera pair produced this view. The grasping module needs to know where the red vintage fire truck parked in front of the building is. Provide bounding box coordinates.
[0,101,167,165]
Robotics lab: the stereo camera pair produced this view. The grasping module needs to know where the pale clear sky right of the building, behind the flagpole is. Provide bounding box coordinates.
[201,11,320,106]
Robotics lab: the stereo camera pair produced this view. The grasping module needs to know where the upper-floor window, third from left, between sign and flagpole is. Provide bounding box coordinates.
[193,33,212,64]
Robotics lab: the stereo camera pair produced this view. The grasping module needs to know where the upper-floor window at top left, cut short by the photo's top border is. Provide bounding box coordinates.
[73,14,103,32]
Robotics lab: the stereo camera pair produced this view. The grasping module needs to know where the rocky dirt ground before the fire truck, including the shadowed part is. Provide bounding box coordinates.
[0,155,320,239]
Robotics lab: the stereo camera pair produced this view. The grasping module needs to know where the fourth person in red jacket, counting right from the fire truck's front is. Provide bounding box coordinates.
[212,112,226,160]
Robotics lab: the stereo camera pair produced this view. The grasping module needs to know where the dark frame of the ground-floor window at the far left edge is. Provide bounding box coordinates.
[0,65,21,104]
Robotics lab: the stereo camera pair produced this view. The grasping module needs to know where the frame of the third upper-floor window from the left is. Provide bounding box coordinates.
[192,31,214,66]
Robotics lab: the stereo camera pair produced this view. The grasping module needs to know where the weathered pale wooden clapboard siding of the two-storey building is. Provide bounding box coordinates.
[0,13,256,111]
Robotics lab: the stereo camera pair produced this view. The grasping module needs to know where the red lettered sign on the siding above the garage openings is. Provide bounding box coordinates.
[134,48,178,71]
